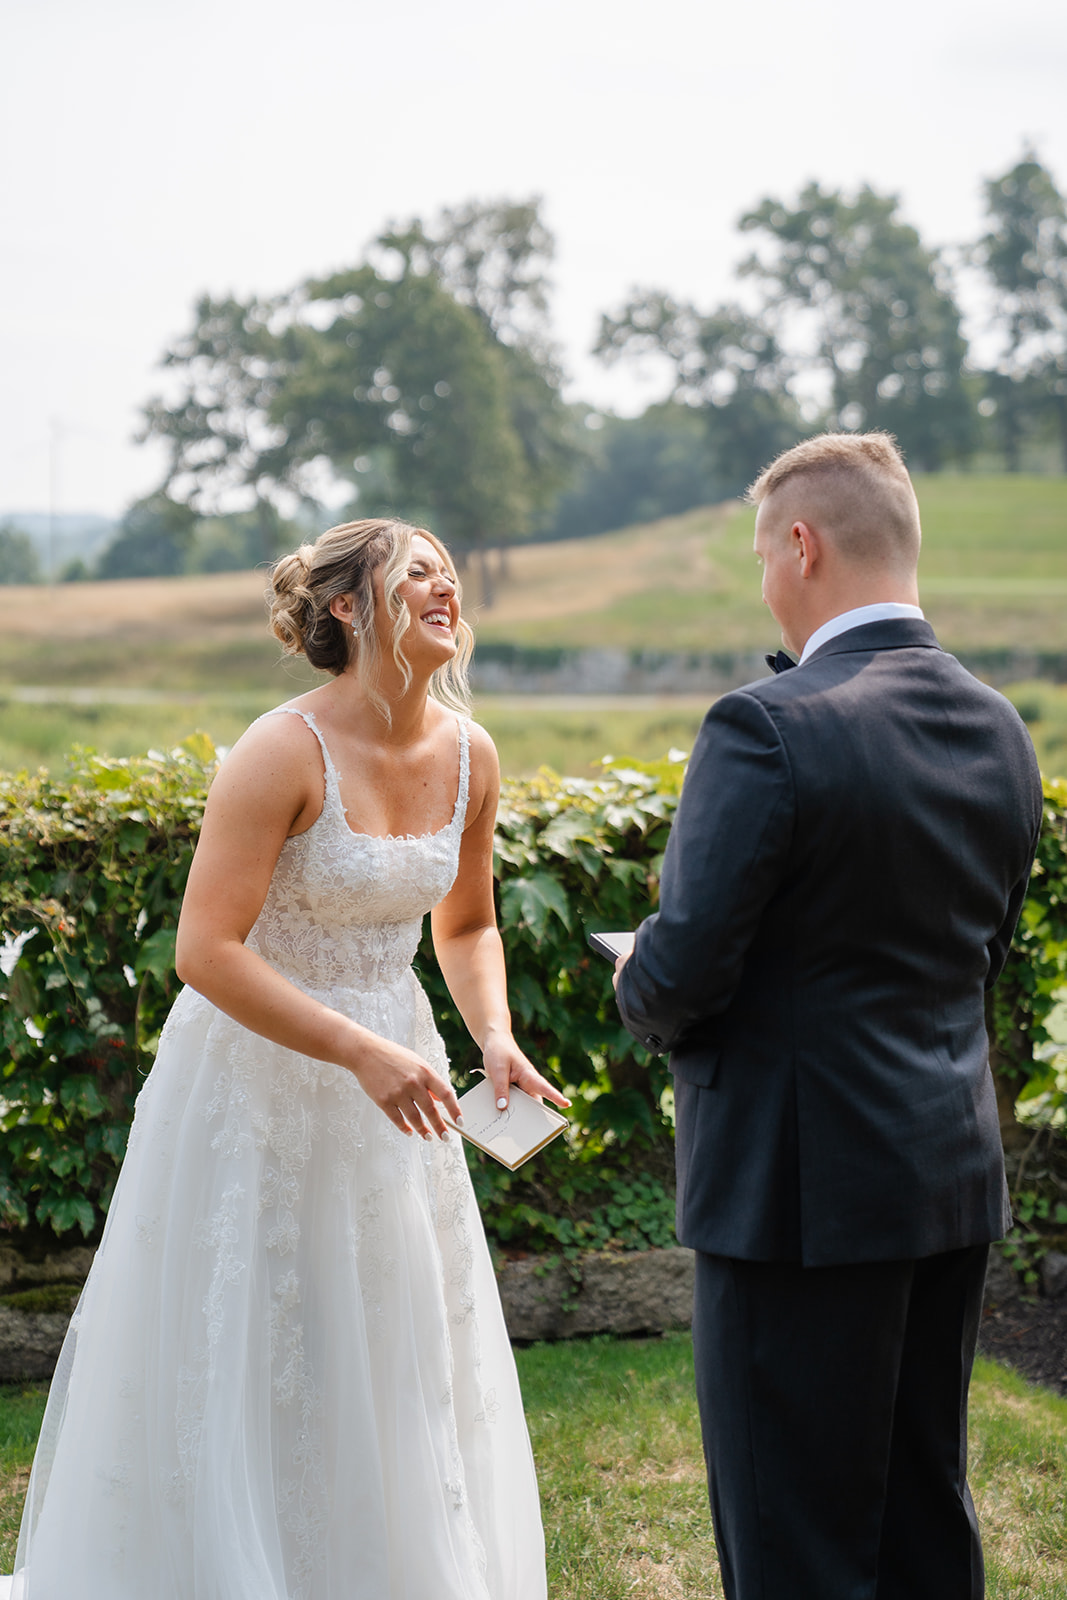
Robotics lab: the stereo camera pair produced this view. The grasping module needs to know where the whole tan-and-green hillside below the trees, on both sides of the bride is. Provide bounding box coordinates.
[0,477,1067,699]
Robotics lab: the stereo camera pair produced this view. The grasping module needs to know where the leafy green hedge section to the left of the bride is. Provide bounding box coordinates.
[0,736,214,1237]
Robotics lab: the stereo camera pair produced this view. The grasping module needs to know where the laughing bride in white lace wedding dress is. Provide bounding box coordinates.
[11,520,568,1600]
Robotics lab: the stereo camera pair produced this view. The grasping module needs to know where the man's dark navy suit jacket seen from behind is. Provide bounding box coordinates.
[619,619,1041,1266]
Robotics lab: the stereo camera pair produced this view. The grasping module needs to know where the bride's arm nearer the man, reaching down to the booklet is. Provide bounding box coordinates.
[430,726,569,1106]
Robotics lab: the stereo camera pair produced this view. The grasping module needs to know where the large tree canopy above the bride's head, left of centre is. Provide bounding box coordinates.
[146,202,576,582]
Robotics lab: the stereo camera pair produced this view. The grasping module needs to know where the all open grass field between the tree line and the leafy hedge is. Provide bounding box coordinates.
[0,477,1067,776]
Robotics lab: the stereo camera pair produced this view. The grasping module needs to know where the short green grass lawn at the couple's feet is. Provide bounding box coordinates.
[0,1334,1067,1600]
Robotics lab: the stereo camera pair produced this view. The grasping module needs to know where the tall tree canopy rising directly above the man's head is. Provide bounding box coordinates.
[597,184,974,488]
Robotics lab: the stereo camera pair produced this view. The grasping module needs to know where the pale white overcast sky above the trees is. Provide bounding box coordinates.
[0,0,1067,514]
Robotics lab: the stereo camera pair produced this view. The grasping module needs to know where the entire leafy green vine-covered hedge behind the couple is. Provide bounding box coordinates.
[0,736,1067,1256]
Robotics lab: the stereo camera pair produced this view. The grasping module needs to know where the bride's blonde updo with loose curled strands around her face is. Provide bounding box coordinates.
[267,517,474,722]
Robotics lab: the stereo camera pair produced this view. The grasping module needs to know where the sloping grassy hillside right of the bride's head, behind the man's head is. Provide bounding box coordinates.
[478,477,1067,651]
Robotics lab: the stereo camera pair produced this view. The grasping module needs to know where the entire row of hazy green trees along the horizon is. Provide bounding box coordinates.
[10,149,1067,598]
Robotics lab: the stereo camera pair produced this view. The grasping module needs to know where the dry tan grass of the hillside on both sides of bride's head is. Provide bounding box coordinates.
[0,502,742,693]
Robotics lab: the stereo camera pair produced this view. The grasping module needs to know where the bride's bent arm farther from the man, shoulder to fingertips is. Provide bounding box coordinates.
[176,717,456,1136]
